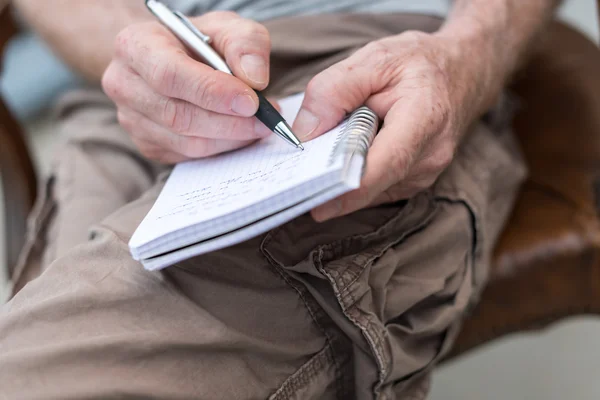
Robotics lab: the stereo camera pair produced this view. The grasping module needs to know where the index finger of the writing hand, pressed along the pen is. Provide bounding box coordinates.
[116,23,258,116]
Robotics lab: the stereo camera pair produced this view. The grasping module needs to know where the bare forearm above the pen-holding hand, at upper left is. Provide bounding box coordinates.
[14,0,149,83]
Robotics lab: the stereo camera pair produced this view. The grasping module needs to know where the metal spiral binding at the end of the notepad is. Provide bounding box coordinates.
[329,106,379,170]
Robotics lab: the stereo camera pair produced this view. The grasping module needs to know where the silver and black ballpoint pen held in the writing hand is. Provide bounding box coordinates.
[146,0,304,150]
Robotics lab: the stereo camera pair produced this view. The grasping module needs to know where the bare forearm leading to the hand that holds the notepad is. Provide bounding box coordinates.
[438,0,560,112]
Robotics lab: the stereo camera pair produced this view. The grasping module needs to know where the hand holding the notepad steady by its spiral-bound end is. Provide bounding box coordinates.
[293,32,490,221]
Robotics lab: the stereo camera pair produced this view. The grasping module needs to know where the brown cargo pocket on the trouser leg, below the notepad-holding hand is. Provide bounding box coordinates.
[315,196,476,398]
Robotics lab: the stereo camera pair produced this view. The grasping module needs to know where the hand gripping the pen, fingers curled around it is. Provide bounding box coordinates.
[102,12,271,163]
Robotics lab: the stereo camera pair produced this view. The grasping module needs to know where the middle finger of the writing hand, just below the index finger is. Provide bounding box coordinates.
[104,64,272,140]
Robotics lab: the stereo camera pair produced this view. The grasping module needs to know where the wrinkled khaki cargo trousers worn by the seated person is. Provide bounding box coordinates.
[0,15,525,399]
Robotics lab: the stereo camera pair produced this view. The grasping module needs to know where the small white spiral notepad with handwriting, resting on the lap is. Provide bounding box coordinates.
[129,93,379,270]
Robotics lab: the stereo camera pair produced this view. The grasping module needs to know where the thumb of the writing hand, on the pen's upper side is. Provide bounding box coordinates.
[192,11,271,90]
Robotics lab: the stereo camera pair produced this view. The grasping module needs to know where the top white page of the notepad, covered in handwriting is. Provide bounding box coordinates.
[130,94,343,253]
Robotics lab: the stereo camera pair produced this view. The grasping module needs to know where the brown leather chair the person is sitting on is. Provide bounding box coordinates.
[0,0,600,366]
